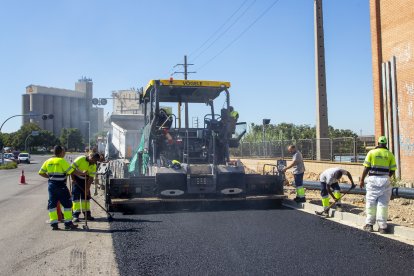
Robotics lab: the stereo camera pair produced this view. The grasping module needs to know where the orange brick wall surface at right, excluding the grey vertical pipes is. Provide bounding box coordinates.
[370,0,414,181]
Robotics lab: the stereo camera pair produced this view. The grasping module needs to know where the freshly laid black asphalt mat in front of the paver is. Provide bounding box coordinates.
[111,202,414,275]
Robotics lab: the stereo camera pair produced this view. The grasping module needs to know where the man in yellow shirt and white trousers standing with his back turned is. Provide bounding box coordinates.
[359,136,397,234]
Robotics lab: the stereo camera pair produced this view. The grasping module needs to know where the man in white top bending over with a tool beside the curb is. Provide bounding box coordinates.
[319,168,355,217]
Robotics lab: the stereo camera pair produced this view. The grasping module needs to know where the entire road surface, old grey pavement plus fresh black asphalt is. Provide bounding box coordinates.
[0,156,414,275]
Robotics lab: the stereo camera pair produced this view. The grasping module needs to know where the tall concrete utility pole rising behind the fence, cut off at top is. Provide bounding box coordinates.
[314,0,329,160]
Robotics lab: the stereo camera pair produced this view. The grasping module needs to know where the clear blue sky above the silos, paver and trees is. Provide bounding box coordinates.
[0,0,374,135]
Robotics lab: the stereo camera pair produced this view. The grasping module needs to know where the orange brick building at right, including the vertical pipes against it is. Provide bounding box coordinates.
[370,0,414,181]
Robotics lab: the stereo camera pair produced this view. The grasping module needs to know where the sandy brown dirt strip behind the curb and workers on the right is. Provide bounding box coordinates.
[285,172,414,228]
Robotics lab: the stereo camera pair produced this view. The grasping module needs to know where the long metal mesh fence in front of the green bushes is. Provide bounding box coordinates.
[231,137,375,162]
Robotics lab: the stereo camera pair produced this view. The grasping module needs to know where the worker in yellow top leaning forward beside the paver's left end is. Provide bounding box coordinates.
[72,153,100,222]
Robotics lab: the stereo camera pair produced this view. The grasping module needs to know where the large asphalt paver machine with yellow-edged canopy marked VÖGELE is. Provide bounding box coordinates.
[105,79,285,211]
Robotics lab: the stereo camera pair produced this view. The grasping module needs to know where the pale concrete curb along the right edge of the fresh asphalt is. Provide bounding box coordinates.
[283,199,414,244]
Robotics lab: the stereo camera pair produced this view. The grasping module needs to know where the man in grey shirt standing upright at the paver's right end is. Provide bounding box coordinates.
[282,145,306,203]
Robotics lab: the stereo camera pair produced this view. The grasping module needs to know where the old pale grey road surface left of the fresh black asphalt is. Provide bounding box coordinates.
[0,156,118,275]
